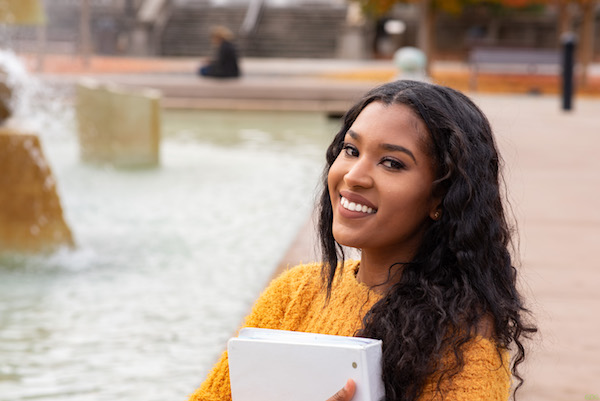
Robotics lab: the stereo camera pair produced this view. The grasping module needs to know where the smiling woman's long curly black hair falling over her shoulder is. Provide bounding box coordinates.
[318,81,537,401]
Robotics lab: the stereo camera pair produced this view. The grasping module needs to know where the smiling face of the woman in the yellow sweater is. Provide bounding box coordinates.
[327,102,440,261]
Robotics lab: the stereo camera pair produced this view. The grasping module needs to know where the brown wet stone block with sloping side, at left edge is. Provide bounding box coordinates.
[0,128,73,252]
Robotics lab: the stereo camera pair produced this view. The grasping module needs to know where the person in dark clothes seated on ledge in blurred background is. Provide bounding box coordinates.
[198,26,240,78]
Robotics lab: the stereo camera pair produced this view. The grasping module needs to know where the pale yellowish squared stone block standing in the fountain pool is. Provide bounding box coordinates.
[75,80,161,167]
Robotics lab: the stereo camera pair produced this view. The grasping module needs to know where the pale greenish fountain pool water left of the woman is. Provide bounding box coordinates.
[0,49,337,401]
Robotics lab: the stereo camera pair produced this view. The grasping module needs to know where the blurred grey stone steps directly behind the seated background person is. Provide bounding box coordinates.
[160,4,346,58]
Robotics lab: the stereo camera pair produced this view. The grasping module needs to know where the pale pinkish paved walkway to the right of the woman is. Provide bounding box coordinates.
[454,96,600,401]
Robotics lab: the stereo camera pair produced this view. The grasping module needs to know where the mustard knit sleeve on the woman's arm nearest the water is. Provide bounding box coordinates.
[189,266,316,401]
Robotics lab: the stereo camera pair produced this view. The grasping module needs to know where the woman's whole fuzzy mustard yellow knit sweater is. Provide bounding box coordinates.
[189,261,510,401]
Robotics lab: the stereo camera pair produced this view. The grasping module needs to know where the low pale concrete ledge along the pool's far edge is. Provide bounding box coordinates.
[45,74,378,112]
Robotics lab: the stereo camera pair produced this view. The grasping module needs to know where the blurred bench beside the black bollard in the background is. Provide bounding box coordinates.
[469,47,561,91]
